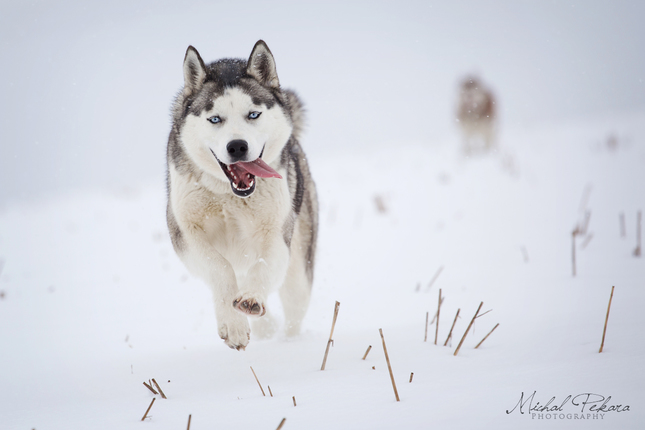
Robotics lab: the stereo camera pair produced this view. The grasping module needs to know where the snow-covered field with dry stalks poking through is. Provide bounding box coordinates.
[0,113,645,430]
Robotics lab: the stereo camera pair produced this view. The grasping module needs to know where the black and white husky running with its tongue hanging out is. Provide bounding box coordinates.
[166,40,318,350]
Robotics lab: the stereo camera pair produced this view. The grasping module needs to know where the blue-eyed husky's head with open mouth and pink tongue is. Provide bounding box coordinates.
[176,40,293,197]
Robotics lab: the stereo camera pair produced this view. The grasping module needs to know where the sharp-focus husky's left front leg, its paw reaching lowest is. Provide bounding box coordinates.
[182,237,251,351]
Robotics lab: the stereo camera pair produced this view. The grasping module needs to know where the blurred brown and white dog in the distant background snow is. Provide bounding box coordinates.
[457,77,495,154]
